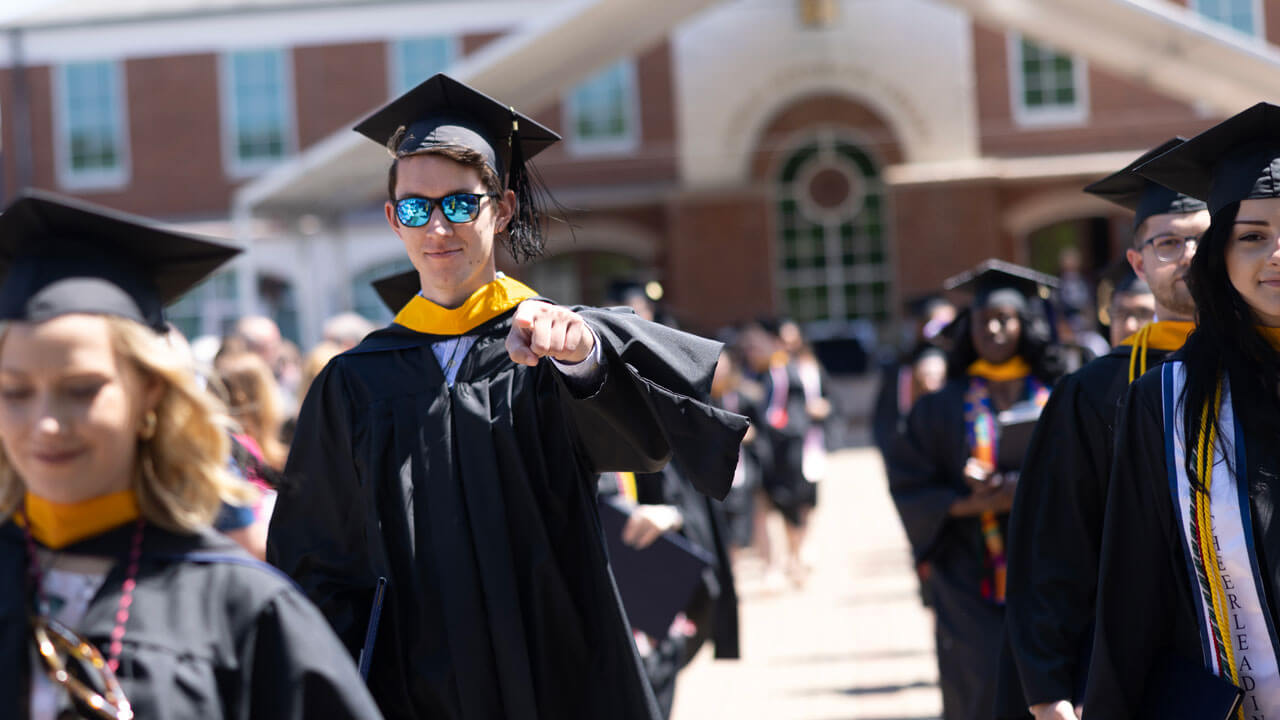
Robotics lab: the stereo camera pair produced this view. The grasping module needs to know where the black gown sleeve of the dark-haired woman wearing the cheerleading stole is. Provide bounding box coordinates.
[1084,373,1181,720]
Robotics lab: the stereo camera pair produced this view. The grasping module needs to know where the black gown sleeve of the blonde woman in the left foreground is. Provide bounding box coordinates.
[241,589,381,720]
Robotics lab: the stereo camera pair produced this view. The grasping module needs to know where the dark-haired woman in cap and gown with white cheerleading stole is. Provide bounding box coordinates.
[1084,104,1280,720]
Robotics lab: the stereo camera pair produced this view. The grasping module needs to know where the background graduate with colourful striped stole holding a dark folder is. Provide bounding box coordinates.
[888,260,1056,720]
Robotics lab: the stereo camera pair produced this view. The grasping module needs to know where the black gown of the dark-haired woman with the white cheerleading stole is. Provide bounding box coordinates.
[1084,366,1280,720]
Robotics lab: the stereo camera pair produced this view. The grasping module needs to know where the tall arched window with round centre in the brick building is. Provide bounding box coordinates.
[777,129,891,324]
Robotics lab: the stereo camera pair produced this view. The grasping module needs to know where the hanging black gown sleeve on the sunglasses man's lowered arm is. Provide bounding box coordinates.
[266,363,378,656]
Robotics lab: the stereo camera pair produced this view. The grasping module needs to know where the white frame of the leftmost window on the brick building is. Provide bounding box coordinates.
[50,60,133,191]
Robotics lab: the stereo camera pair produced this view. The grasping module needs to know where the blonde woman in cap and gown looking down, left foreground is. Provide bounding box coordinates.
[0,189,379,720]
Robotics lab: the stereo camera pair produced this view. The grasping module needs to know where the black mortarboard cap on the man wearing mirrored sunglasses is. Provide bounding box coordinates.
[355,73,559,178]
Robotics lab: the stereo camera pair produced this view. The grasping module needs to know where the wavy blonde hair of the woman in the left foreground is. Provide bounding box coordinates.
[0,315,256,533]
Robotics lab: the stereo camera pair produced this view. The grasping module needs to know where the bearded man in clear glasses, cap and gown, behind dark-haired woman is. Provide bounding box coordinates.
[1001,138,1208,720]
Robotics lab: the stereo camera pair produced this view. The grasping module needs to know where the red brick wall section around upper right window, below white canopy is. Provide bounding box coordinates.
[973,23,1215,156]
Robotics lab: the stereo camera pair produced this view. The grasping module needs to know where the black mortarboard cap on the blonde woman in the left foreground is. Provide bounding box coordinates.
[0,191,239,331]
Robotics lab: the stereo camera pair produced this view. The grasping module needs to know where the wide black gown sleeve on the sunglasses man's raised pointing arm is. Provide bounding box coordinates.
[562,309,748,500]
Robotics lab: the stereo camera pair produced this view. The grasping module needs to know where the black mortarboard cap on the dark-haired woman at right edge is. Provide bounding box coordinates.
[1138,102,1280,213]
